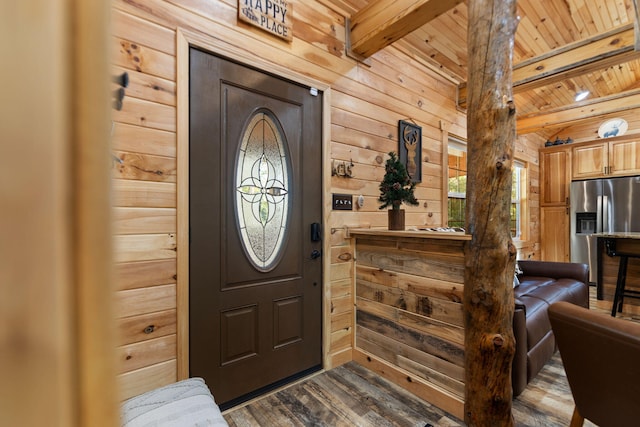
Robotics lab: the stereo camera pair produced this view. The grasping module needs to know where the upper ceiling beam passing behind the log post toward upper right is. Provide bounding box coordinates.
[457,24,640,108]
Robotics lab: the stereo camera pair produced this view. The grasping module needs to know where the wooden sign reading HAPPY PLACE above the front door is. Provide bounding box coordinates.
[238,0,293,41]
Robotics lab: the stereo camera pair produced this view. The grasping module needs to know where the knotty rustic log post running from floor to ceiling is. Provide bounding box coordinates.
[463,0,517,426]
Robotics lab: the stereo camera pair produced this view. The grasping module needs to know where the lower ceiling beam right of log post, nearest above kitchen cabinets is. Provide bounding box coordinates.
[516,89,640,135]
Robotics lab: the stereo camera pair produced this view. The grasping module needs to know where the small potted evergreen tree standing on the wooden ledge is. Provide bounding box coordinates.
[378,151,418,230]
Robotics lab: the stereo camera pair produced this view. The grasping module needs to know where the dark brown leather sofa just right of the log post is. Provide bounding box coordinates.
[511,260,589,397]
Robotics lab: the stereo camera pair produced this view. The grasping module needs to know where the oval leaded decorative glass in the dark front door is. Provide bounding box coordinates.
[235,109,291,272]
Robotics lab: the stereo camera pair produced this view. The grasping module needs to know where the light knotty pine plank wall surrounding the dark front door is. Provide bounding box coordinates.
[112,0,539,398]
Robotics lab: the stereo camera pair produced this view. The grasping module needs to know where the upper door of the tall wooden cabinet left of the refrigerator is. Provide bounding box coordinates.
[540,149,571,206]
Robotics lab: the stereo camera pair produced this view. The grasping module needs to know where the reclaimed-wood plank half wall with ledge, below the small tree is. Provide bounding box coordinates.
[350,230,471,419]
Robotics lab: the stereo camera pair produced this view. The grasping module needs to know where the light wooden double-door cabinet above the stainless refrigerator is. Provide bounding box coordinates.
[572,140,640,179]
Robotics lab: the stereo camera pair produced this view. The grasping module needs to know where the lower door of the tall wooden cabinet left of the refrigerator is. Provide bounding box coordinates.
[540,206,569,262]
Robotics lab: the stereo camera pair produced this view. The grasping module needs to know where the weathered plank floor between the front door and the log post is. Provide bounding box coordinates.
[224,362,462,427]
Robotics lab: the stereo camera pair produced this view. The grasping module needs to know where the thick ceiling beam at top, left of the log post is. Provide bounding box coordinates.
[347,0,463,58]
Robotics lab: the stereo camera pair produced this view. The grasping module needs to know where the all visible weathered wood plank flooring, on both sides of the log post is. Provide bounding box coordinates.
[223,293,616,427]
